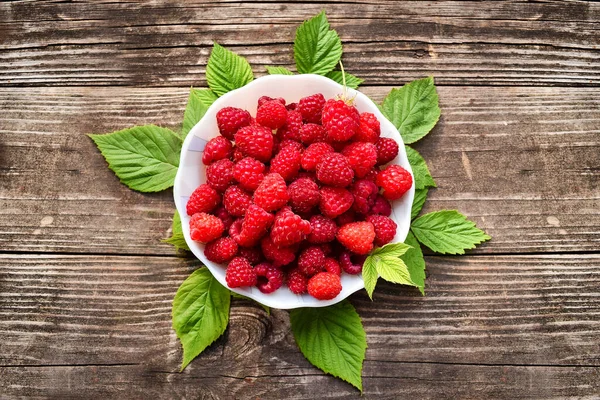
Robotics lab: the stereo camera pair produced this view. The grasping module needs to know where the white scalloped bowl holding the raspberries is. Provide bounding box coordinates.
[173,74,415,309]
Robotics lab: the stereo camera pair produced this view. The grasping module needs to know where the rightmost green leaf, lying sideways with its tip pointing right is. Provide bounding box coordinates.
[411,210,491,254]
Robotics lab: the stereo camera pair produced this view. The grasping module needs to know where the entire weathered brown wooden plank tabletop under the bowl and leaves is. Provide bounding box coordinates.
[0,0,600,399]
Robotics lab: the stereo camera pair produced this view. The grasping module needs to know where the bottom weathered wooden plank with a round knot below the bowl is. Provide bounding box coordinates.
[0,255,600,399]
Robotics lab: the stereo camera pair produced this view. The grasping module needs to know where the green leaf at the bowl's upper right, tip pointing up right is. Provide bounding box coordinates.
[382,77,440,144]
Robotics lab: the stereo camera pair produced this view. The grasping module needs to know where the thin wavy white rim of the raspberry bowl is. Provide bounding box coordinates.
[173,74,415,309]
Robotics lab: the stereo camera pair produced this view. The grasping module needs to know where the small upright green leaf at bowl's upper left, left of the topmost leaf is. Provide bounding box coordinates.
[206,43,254,96]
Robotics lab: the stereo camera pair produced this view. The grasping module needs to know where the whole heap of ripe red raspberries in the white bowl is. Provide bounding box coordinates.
[187,93,412,300]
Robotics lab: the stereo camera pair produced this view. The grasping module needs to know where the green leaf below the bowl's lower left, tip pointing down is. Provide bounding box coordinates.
[172,268,231,371]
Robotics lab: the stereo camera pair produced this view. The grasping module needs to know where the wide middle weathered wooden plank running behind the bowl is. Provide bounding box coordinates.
[0,87,600,254]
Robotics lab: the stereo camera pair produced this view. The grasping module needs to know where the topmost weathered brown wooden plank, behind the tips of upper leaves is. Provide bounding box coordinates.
[0,1,600,86]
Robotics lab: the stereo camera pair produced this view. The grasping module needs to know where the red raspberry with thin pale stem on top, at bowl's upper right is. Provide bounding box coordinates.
[323,99,360,142]
